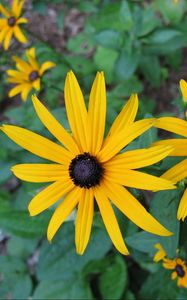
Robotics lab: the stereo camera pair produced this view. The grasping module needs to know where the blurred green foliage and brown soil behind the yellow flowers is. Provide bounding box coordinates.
[0,0,187,300]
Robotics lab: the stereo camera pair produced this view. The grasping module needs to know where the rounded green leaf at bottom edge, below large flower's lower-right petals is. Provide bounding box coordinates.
[99,255,127,299]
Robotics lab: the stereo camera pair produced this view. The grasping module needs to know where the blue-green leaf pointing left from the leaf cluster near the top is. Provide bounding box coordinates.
[94,30,123,49]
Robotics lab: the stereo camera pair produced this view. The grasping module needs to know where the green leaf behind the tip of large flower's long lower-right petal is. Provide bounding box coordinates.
[150,189,181,258]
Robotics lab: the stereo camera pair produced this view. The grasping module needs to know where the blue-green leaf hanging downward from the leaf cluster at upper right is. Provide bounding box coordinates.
[115,49,139,81]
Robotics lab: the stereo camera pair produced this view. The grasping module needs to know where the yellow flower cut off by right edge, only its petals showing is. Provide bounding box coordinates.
[154,117,187,221]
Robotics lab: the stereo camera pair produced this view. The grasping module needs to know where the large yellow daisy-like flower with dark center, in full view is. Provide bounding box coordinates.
[1,72,174,255]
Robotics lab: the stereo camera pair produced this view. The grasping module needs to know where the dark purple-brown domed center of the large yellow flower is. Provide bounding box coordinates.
[69,152,103,189]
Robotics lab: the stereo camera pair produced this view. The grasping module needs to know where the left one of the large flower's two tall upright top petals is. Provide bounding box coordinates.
[64,71,88,152]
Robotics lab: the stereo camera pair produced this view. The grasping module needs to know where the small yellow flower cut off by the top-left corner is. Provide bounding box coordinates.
[0,0,28,50]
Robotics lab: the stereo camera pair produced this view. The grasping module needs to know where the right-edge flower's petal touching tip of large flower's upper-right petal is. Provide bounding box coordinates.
[154,117,187,137]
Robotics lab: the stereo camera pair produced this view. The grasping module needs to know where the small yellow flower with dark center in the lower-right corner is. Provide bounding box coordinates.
[163,257,187,288]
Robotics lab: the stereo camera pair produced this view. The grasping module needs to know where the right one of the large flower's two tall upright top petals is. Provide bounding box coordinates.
[88,72,106,155]
